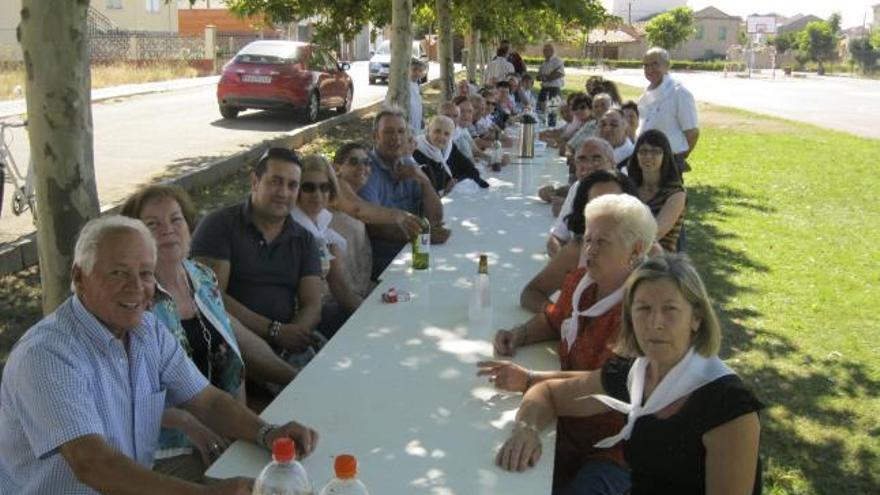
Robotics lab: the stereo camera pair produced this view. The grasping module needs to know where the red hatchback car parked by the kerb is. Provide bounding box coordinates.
[217,40,354,122]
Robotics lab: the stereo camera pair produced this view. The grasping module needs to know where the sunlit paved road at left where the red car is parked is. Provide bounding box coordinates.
[0,62,439,243]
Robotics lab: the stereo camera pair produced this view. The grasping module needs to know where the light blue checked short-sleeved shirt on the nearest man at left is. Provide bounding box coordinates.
[0,296,208,495]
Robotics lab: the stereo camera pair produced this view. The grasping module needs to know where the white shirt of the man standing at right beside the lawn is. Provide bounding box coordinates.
[638,74,697,154]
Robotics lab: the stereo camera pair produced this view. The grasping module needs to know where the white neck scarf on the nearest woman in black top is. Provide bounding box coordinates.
[584,347,735,448]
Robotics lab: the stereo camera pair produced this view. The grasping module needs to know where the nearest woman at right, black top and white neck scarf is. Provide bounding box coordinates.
[496,254,763,495]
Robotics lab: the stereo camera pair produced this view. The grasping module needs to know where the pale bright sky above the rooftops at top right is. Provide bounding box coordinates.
[688,0,880,29]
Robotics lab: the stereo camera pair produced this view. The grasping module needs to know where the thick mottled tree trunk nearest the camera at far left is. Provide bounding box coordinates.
[18,0,99,313]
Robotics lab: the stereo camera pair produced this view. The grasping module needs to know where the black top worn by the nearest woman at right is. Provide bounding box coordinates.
[602,358,764,495]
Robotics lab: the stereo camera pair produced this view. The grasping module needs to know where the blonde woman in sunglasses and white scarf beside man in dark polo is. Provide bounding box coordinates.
[291,155,364,338]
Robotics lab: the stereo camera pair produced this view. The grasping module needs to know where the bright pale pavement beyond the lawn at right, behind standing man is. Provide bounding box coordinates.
[602,69,880,139]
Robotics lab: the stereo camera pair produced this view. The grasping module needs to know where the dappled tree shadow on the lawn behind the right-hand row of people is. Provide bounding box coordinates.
[687,185,880,493]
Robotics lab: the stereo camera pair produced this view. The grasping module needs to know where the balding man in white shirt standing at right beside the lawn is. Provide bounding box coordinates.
[639,47,700,172]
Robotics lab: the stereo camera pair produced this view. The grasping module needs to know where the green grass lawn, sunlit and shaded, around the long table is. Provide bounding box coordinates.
[0,77,880,495]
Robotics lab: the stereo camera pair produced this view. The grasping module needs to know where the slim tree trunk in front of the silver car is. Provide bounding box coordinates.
[385,0,412,115]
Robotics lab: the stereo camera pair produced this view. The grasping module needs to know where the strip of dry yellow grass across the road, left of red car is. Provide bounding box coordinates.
[0,61,198,101]
